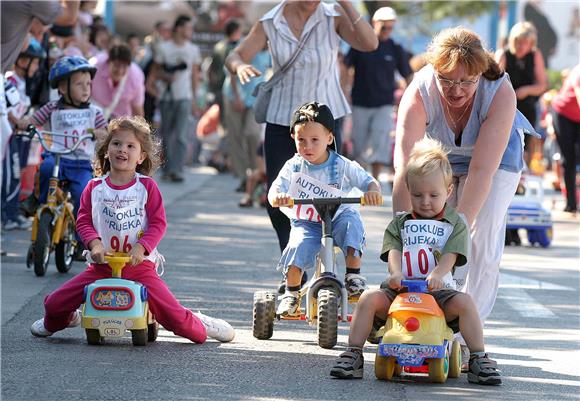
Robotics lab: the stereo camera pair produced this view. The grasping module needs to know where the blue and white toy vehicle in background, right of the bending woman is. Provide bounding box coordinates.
[506,175,554,248]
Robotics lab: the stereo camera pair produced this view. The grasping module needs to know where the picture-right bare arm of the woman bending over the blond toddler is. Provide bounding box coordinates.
[457,81,516,227]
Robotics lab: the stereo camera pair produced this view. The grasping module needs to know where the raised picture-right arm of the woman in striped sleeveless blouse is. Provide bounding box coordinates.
[336,0,379,52]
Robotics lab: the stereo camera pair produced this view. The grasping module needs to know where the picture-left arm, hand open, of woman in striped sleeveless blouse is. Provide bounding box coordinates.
[225,21,268,85]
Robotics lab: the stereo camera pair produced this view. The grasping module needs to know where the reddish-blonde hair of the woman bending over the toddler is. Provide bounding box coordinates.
[426,27,503,81]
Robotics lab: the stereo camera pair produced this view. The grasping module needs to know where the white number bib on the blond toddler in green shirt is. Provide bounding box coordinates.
[401,220,454,288]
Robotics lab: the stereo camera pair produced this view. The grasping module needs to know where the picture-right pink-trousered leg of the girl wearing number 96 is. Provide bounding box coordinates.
[123,264,207,344]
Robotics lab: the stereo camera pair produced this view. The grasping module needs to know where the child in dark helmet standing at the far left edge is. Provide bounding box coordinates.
[2,38,46,231]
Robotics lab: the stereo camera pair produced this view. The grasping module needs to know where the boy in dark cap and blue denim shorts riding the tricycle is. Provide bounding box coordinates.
[268,102,381,317]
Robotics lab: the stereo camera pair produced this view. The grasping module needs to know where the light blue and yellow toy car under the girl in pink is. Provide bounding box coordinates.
[81,253,159,346]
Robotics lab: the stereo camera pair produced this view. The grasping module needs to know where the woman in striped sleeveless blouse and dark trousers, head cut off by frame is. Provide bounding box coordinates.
[226,0,378,250]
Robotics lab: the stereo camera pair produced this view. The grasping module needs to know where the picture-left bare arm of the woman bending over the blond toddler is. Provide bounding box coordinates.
[393,85,427,213]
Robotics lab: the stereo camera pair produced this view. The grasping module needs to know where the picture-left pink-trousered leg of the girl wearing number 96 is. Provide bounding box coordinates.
[44,265,111,333]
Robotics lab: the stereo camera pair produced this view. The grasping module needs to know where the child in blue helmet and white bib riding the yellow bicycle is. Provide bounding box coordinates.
[20,56,107,254]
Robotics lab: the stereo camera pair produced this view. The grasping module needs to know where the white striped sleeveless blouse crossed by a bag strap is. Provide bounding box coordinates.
[260,1,350,126]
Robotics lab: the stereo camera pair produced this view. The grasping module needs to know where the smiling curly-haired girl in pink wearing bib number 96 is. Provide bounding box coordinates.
[31,117,235,343]
